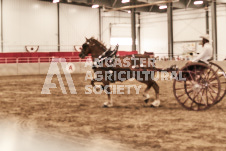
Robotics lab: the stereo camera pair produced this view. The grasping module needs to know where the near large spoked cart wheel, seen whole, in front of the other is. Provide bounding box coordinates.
[173,63,221,110]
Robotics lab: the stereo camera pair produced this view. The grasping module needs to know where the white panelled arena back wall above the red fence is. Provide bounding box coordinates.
[1,0,226,60]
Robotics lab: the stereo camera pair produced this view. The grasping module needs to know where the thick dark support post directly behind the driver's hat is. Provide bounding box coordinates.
[211,0,217,60]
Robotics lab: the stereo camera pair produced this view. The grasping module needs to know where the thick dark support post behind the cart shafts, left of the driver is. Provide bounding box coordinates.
[167,3,173,59]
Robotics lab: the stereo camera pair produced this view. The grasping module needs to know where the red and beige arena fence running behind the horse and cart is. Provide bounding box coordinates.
[0,52,226,76]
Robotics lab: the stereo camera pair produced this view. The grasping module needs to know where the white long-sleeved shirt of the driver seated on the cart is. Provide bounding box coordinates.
[192,43,213,63]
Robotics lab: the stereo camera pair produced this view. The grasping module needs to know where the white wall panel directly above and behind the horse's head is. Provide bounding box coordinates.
[60,4,99,51]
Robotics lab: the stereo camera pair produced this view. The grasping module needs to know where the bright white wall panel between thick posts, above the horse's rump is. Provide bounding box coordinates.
[141,13,168,55]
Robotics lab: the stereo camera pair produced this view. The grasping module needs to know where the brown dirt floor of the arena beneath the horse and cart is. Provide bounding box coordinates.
[0,74,226,151]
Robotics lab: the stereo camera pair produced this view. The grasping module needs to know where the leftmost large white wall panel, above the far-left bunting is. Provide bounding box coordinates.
[3,0,57,52]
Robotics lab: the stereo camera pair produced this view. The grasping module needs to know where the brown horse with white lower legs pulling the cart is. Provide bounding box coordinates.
[79,38,160,107]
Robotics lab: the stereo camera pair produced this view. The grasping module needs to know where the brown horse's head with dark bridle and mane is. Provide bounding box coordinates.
[79,38,106,58]
